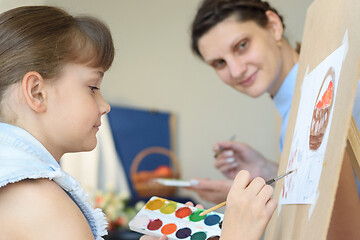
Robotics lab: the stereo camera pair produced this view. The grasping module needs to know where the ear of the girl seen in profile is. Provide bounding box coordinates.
[22,71,47,113]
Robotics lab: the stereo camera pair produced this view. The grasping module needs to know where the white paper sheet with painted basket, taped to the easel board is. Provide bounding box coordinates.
[280,33,348,204]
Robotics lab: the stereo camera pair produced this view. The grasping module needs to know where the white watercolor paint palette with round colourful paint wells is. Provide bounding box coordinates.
[129,197,224,240]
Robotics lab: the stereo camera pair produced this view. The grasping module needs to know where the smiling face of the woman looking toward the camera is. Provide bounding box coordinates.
[198,16,282,97]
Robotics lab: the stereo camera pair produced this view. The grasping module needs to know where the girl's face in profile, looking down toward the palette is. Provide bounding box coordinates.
[44,64,110,156]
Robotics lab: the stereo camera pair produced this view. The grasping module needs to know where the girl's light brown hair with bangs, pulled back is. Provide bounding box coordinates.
[0,6,114,102]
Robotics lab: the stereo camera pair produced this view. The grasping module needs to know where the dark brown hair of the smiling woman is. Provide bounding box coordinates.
[191,0,285,58]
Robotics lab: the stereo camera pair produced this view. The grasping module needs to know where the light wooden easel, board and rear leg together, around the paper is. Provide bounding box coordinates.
[265,0,360,240]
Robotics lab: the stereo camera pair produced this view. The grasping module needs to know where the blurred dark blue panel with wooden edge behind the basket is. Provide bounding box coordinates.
[108,106,183,202]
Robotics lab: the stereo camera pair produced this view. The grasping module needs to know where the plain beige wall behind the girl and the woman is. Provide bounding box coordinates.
[0,0,312,206]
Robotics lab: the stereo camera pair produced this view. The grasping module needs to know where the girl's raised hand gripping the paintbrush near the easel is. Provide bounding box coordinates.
[221,170,276,240]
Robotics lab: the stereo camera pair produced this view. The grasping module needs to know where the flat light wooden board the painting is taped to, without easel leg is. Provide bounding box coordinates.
[265,0,360,240]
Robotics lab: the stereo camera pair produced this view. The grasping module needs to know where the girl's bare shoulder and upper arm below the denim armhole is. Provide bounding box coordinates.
[0,179,93,240]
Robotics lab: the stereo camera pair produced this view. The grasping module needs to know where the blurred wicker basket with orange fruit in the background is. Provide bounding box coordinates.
[130,147,180,197]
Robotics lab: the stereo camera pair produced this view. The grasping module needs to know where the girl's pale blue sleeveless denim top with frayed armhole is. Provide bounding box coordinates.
[0,123,107,240]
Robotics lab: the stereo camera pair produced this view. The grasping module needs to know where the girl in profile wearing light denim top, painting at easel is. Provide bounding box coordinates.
[0,6,276,240]
